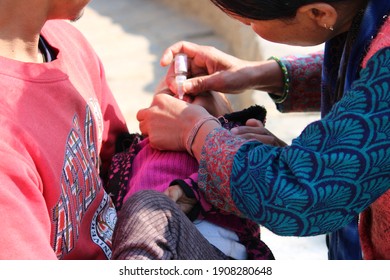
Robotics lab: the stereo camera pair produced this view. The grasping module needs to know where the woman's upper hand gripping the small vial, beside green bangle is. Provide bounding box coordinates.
[160,42,272,97]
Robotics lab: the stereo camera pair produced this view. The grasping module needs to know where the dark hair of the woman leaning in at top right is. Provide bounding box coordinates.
[211,0,346,20]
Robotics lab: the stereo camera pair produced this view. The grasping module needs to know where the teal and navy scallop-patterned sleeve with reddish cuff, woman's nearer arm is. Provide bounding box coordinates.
[199,48,390,236]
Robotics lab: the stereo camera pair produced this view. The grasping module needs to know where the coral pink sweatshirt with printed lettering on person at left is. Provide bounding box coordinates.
[0,21,127,259]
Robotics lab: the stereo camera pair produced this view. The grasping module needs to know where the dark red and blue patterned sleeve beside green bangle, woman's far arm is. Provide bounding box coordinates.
[270,52,323,113]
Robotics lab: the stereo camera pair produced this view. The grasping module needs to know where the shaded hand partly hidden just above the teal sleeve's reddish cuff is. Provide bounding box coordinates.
[231,119,287,147]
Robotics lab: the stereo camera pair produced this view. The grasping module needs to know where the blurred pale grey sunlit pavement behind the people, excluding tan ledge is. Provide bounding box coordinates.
[74,0,327,260]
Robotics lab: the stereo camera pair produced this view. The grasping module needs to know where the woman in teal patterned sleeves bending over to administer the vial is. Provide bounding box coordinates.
[133,0,390,258]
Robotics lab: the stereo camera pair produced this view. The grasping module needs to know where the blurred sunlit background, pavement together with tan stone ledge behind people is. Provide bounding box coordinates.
[74,0,327,260]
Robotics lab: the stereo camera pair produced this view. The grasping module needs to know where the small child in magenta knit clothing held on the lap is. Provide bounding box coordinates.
[107,92,274,259]
